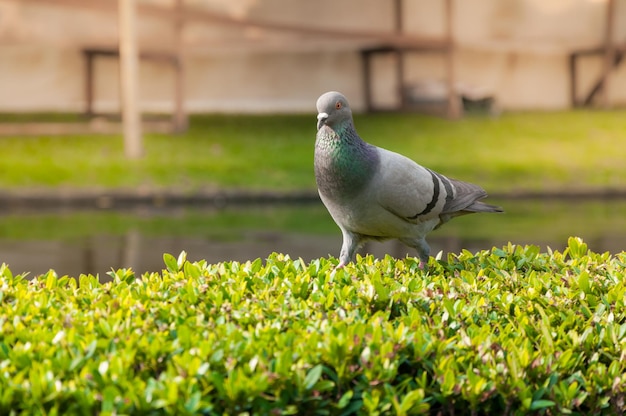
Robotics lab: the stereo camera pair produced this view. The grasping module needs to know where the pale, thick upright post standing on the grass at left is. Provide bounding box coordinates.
[118,0,143,159]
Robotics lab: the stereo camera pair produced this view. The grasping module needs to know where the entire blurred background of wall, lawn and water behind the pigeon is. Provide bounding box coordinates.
[0,0,626,276]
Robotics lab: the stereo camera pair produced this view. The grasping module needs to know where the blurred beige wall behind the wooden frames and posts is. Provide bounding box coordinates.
[0,0,626,112]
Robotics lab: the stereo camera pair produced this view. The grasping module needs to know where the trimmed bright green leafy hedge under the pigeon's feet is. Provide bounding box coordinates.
[0,238,626,415]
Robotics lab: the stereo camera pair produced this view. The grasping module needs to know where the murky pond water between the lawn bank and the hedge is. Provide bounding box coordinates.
[0,199,626,279]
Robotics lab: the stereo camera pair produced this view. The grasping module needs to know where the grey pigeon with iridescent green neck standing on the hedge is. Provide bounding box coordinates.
[314,91,503,269]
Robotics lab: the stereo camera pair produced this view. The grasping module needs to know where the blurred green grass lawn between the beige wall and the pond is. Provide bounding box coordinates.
[0,110,626,193]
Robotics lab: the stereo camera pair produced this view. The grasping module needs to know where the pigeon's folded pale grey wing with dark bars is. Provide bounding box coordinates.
[370,149,454,222]
